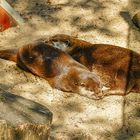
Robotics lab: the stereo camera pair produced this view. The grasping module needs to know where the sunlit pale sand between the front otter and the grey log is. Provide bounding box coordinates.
[0,57,139,139]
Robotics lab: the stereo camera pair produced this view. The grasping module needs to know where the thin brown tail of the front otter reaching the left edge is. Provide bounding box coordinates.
[0,49,18,62]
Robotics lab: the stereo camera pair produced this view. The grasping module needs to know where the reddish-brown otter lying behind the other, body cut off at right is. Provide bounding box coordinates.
[49,34,140,95]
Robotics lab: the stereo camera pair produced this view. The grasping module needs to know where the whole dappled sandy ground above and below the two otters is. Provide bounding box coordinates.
[0,0,140,140]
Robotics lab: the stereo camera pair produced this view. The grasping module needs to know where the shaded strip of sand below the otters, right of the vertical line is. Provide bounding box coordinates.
[116,93,140,140]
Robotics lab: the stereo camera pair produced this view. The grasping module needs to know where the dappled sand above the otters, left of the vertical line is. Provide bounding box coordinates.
[0,0,128,47]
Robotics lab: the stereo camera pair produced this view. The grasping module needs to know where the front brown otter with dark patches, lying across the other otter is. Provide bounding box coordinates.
[0,42,102,98]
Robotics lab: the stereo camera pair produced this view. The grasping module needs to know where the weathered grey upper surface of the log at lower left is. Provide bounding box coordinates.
[0,87,52,126]
